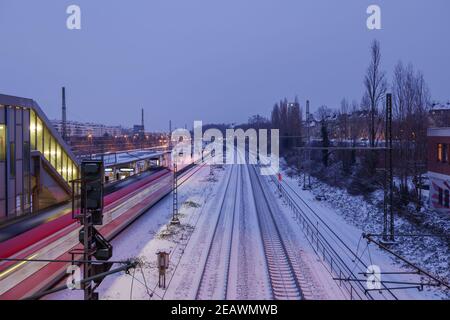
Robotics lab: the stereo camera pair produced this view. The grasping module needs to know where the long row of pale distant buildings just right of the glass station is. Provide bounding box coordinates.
[52,120,125,137]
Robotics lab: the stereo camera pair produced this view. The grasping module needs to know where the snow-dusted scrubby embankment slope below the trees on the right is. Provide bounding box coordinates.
[283,164,450,298]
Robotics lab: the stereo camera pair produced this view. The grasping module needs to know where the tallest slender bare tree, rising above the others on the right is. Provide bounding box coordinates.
[364,40,387,147]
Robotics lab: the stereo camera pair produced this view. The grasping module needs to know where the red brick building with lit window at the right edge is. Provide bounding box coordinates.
[428,128,450,213]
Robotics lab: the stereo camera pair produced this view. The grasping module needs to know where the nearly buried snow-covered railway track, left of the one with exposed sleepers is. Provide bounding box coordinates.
[195,166,242,300]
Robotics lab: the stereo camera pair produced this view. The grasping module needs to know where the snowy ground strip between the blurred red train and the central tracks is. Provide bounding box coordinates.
[46,167,224,300]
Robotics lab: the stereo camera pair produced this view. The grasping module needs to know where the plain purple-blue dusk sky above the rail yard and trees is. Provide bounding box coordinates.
[0,0,450,131]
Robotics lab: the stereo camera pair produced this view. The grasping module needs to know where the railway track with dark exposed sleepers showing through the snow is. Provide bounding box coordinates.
[249,166,304,300]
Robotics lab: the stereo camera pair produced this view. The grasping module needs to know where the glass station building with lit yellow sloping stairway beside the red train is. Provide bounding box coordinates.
[0,94,79,223]
